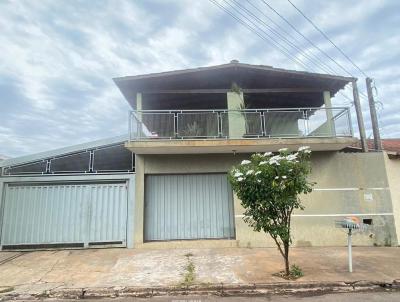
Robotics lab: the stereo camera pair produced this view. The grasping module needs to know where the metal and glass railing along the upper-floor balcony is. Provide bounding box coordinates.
[129,107,353,140]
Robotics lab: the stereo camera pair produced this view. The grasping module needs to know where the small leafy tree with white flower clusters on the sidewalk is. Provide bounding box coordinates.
[229,147,314,276]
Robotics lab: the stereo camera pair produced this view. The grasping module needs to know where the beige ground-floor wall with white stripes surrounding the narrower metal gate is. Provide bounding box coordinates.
[135,152,397,248]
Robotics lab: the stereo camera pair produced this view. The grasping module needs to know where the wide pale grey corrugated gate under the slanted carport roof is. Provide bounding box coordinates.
[1,182,127,249]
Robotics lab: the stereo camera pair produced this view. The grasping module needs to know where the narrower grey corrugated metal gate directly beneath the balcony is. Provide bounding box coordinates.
[144,174,235,241]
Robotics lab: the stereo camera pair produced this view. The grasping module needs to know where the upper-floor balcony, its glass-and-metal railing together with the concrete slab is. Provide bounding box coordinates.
[127,107,354,154]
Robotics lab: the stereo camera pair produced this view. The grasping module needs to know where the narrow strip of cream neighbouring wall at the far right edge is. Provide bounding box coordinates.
[384,153,400,244]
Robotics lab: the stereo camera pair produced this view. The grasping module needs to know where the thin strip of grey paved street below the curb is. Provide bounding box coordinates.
[52,292,400,302]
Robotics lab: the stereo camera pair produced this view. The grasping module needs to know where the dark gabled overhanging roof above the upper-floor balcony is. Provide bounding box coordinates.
[113,61,354,107]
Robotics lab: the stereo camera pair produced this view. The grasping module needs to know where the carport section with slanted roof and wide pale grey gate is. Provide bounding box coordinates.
[0,135,135,250]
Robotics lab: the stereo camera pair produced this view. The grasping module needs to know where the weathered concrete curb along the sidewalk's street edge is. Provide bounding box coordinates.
[0,279,400,301]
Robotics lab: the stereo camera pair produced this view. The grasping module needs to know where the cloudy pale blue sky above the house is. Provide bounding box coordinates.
[0,0,400,157]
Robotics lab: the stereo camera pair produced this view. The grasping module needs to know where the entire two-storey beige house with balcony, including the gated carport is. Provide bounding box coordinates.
[0,61,397,249]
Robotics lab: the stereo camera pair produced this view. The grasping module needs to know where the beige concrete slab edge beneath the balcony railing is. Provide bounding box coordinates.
[125,137,357,154]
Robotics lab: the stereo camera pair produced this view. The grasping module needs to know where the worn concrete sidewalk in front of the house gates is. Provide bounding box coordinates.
[0,247,400,295]
